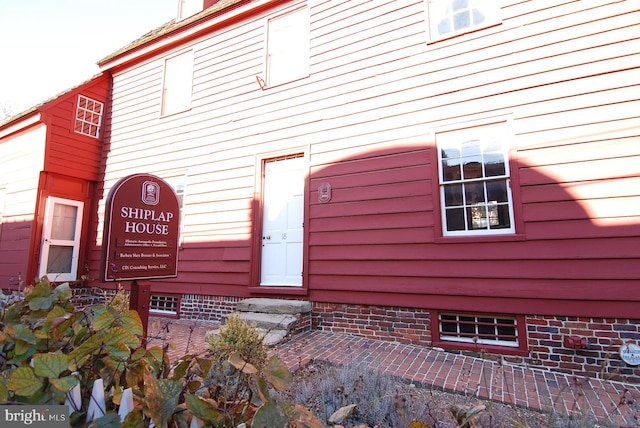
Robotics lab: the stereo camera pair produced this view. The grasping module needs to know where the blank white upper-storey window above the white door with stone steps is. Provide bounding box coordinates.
[267,7,310,86]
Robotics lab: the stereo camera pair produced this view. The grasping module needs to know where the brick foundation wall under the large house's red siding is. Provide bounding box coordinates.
[67,288,640,383]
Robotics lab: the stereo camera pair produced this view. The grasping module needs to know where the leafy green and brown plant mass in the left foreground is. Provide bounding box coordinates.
[0,278,321,428]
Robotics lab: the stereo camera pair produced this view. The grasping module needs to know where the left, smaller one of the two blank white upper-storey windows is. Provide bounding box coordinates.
[161,51,193,116]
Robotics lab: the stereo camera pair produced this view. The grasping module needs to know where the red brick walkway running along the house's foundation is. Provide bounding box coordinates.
[148,319,640,426]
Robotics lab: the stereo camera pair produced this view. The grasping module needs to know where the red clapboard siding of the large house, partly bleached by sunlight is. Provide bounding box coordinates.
[91,0,640,317]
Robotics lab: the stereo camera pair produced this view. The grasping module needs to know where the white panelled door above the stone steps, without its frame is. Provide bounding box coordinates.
[260,157,306,287]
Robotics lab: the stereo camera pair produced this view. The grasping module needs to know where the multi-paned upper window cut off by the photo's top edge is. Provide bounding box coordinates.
[427,0,500,40]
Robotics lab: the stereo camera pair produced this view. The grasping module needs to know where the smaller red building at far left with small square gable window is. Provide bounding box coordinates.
[0,74,110,292]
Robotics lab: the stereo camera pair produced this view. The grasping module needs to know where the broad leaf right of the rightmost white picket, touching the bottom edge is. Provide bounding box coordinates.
[144,372,183,427]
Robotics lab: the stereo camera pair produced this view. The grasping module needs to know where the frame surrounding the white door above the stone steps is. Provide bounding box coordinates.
[248,146,310,295]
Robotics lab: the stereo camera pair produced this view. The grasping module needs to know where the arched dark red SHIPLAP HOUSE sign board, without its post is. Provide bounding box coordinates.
[101,174,180,281]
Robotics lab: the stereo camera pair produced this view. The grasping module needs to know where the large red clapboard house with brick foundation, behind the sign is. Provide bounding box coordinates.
[0,0,640,382]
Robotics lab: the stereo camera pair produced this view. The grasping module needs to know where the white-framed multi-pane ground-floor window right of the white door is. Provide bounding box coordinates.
[436,123,515,236]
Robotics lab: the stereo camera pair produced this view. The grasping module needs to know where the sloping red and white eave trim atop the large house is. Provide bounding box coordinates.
[97,0,285,71]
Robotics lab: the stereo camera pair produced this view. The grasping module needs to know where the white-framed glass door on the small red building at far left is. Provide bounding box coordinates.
[39,196,84,282]
